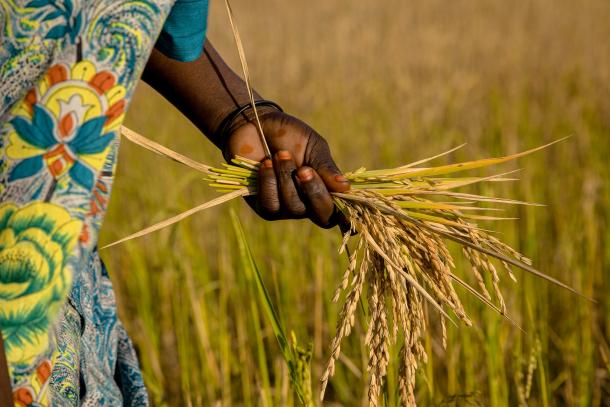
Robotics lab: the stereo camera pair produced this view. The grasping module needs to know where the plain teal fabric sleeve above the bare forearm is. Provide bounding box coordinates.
[155,0,208,62]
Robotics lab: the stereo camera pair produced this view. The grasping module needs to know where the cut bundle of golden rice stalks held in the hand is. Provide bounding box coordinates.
[105,128,580,406]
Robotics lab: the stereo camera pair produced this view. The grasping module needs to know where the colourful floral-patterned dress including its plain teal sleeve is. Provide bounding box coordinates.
[0,0,207,406]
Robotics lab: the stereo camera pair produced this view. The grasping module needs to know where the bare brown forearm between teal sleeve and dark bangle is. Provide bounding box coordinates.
[142,41,260,147]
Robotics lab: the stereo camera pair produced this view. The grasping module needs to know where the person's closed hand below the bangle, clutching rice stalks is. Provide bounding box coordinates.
[223,112,350,228]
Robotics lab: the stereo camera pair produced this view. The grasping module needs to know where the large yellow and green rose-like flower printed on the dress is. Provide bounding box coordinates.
[0,202,82,370]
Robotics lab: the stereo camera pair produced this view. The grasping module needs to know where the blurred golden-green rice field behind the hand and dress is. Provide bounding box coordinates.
[101,0,610,406]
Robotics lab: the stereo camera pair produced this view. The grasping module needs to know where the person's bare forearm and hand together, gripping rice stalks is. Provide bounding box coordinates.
[143,41,350,227]
